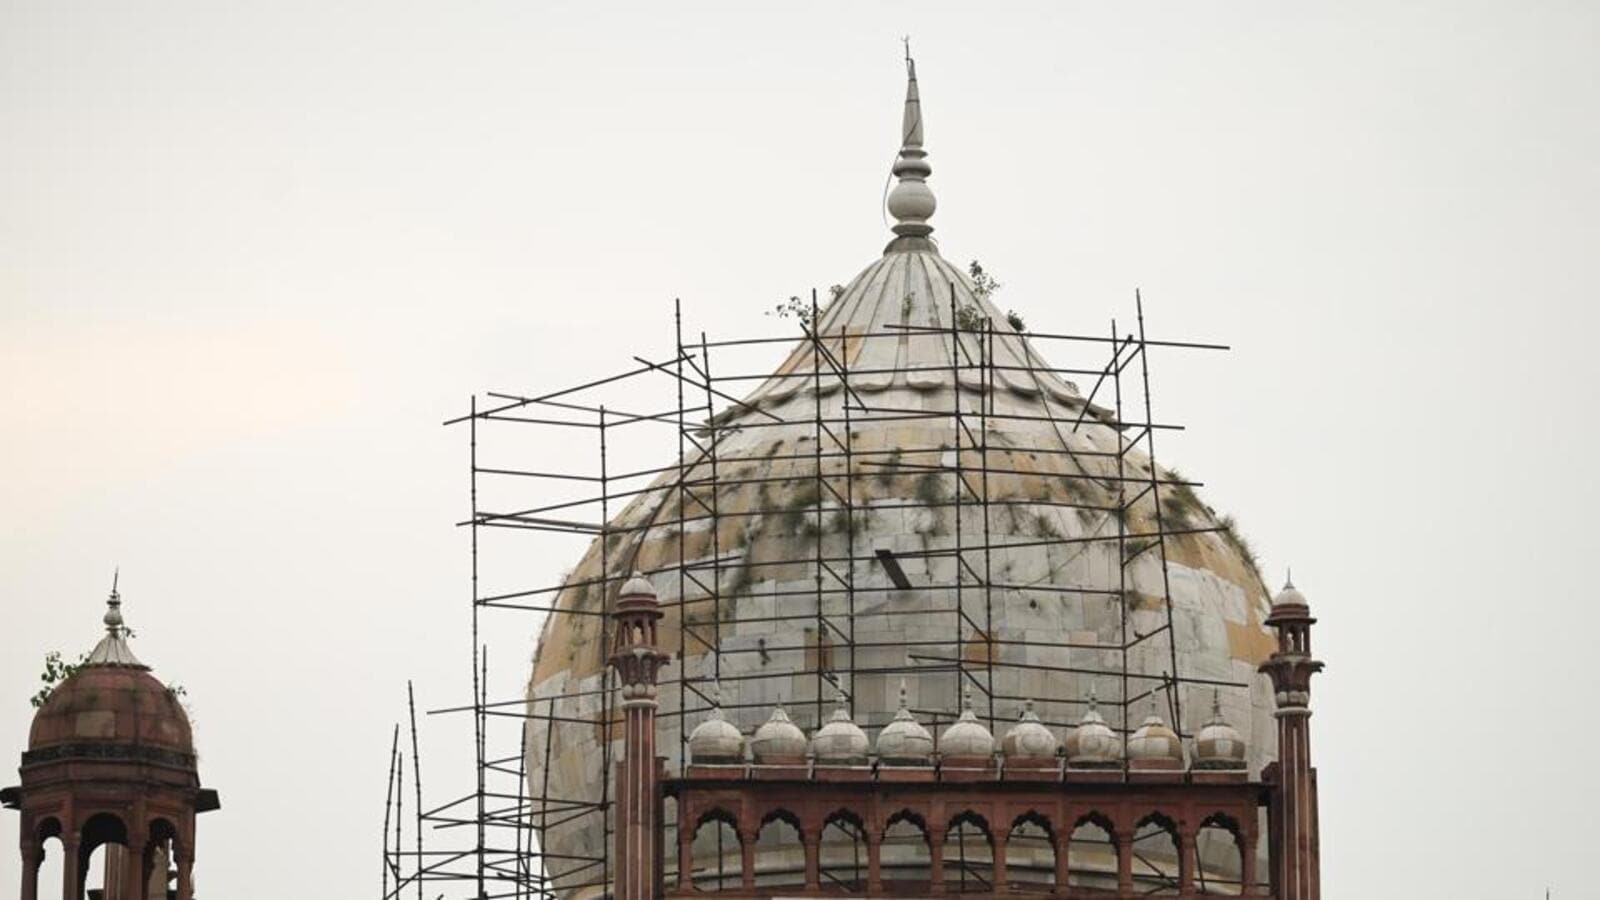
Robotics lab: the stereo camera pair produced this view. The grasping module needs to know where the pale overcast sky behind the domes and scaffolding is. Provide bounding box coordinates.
[0,0,1600,900]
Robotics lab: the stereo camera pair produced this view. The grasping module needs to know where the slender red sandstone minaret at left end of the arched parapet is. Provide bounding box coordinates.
[611,573,667,900]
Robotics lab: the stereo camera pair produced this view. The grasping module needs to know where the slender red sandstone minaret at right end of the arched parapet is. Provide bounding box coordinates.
[1261,581,1322,900]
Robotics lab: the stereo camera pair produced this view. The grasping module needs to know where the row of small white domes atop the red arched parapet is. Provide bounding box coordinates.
[690,681,1245,769]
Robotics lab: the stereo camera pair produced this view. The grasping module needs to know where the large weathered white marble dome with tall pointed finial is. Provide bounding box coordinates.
[526,57,1274,895]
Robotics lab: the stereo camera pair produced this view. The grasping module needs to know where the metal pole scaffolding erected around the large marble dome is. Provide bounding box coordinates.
[382,285,1248,900]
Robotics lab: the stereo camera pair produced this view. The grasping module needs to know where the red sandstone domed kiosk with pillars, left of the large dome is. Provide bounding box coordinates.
[0,588,221,900]
